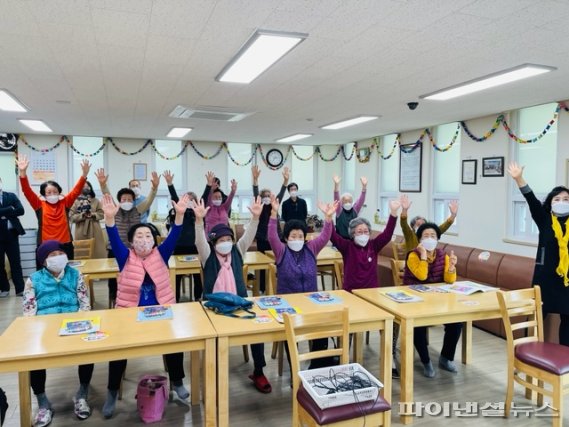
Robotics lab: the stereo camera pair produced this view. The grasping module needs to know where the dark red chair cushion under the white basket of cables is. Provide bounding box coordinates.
[296,384,391,425]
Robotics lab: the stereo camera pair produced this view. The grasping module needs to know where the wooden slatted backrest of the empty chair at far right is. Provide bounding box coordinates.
[497,286,543,360]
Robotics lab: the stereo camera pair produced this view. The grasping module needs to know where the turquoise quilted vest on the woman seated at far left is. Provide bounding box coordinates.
[30,266,79,315]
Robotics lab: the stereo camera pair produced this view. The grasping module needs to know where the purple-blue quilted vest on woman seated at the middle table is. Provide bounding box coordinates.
[277,244,318,294]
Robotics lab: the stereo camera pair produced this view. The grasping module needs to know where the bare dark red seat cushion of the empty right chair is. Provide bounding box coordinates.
[515,342,569,375]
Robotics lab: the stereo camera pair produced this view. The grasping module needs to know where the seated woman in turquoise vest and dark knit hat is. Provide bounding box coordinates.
[23,240,94,427]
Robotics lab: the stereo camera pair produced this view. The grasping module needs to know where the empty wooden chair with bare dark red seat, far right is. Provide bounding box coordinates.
[497,286,569,427]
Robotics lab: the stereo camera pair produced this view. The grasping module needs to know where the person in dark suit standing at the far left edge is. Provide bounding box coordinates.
[0,178,26,298]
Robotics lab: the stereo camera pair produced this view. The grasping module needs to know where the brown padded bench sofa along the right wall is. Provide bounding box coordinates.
[377,236,559,342]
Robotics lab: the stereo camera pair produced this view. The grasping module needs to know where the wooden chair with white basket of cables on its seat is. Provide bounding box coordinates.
[284,308,391,427]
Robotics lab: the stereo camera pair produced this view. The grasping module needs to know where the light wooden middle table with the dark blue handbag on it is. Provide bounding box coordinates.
[207,291,393,426]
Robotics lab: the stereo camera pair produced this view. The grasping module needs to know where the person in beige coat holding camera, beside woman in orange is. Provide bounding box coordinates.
[69,181,107,258]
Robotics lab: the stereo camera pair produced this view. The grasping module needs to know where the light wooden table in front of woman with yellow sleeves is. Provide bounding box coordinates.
[353,286,501,424]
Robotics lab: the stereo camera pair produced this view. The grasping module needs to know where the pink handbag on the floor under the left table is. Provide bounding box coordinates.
[136,375,169,423]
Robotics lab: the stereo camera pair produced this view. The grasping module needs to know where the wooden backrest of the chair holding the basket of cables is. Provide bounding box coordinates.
[284,308,350,390]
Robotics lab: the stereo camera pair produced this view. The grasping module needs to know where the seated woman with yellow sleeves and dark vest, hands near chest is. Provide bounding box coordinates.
[403,222,462,378]
